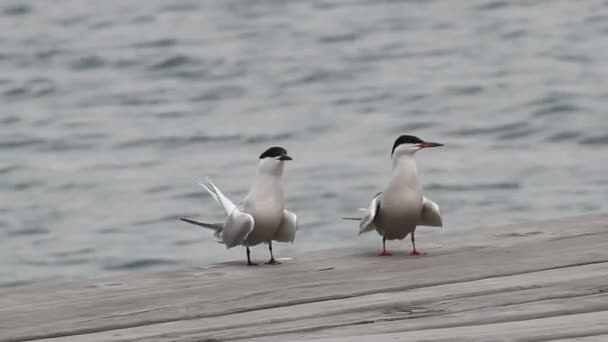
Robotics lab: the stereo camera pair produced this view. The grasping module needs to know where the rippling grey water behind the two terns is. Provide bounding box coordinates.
[0,0,608,287]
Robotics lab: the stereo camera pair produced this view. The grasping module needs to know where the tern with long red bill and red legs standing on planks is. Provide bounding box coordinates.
[344,135,443,256]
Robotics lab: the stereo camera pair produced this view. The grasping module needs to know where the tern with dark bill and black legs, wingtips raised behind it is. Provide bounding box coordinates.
[181,147,298,266]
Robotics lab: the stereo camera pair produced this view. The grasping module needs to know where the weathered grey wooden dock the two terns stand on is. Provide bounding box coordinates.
[0,215,608,342]
